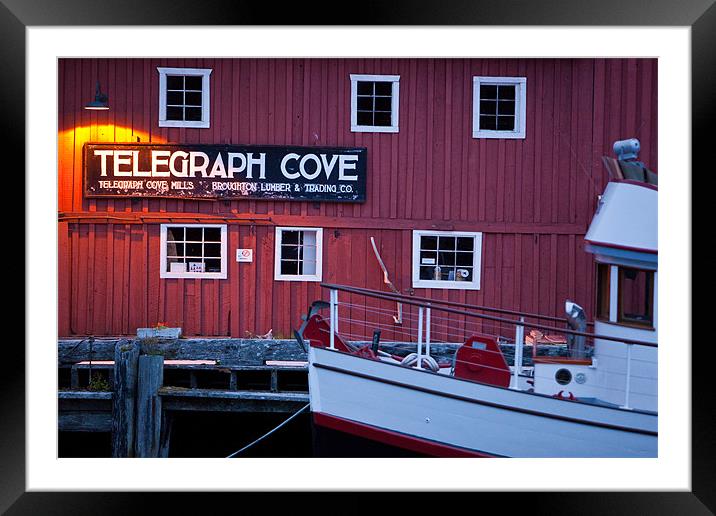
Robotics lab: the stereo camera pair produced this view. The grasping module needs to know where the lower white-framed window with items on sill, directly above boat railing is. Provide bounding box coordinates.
[413,230,482,290]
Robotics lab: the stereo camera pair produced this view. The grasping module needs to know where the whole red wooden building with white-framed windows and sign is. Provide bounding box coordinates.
[58,59,658,337]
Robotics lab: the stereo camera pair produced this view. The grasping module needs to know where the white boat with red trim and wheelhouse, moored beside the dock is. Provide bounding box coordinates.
[296,139,658,457]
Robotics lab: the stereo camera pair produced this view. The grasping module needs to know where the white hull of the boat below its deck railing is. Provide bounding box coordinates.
[309,347,658,457]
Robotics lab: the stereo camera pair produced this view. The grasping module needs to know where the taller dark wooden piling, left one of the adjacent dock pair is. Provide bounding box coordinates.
[112,340,139,457]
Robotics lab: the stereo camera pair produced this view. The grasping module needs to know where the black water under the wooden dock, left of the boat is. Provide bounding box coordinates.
[58,411,313,458]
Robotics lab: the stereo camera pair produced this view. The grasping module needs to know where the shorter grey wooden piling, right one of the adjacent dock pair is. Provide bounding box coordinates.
[135,355,164,458]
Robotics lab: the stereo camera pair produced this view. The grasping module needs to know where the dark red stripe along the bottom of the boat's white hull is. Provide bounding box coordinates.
[313,412,494,458]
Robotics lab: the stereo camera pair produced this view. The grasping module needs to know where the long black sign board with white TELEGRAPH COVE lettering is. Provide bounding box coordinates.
[84,143,367,202]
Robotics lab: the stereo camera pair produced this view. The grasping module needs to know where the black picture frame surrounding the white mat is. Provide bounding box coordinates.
[0,0,716,515]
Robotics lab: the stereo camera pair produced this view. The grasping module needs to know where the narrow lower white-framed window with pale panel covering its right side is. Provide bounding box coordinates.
[274,227,323,281]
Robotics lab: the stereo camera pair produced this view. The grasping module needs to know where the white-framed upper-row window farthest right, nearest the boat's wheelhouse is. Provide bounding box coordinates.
[472,77,527,138]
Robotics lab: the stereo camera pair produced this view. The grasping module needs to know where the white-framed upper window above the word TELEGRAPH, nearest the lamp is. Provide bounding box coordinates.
[157,67,211,128]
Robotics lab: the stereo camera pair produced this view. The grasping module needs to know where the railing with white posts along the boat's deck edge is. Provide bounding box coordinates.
[321,283,657,407]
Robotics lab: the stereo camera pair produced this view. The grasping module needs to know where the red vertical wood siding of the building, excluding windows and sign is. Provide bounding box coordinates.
[58,59,658,337]
